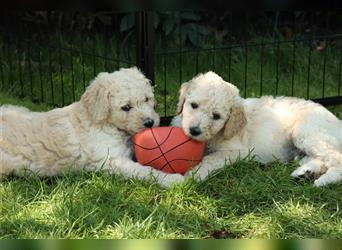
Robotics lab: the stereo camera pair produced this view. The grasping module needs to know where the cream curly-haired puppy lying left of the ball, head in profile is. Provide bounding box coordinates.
[0,67,184,186]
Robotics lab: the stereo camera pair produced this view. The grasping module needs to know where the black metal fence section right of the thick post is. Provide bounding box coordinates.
[150,12,342,116]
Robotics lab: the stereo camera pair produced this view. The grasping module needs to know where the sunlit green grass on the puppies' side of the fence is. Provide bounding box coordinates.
[0,95,342,239]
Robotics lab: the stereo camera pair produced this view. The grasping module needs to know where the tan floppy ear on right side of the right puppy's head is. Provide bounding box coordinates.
[224,99,247,140]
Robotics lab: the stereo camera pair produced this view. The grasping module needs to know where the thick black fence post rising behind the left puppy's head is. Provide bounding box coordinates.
[135,11,155,85]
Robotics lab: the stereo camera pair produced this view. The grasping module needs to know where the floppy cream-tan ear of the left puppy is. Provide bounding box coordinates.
[81,74,110,123]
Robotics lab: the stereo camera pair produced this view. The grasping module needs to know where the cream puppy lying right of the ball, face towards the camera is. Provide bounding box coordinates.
[172,72,342,186]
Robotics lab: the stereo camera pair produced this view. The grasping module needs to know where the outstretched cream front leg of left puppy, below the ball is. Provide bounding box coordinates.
[110,158,185,187]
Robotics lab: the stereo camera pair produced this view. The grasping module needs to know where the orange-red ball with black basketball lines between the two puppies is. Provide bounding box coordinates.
[133,127,205,174]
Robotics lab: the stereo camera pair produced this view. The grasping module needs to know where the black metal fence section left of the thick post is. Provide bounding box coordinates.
[0,11,136,107]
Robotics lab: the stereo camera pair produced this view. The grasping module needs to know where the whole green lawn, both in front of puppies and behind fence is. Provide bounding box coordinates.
[0,31,342,239]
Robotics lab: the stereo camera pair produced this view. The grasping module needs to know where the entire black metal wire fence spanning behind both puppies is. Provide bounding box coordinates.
[0,11,342,116]
